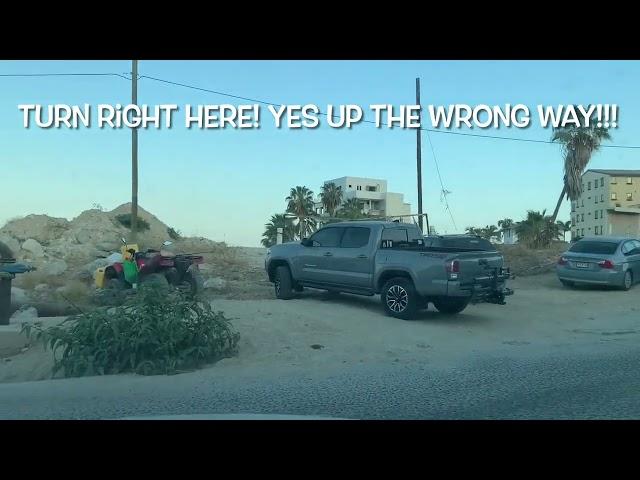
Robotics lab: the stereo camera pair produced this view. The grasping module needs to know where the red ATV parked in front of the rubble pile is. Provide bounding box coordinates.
[102,238,204,295]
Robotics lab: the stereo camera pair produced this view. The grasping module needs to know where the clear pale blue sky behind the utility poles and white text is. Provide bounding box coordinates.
[0,60,640,246]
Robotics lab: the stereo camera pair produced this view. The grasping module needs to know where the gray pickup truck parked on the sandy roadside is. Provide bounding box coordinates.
[265,221,513,320]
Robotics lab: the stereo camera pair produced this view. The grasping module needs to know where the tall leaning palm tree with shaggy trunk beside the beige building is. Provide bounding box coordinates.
[551,106,611,222]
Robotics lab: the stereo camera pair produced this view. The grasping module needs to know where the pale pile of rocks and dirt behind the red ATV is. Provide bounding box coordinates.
[0,204,235,318]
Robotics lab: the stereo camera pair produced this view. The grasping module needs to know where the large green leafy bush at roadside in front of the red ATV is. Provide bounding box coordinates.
[22,285,240,377]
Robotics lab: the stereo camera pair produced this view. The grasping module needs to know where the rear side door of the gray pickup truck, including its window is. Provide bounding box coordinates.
[330,227,374,288]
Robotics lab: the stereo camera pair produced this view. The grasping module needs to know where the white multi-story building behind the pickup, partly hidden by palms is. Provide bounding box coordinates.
[315,177,412,217]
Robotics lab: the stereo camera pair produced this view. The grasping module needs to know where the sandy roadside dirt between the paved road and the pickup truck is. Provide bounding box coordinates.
[0,272,640,382]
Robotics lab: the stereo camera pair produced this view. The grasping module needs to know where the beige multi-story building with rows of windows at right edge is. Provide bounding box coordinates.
[571,169,640,239]
